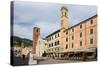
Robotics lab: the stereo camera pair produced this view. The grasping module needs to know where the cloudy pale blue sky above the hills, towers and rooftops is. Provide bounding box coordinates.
[13,1,97,40]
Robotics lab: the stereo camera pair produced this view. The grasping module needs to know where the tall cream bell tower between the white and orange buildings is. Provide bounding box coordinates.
[60,6,68,49]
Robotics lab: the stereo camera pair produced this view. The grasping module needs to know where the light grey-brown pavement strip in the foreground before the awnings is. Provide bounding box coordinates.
[38,59,81,64]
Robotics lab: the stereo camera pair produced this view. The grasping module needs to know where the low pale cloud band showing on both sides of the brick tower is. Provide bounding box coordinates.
[14,21,60,40]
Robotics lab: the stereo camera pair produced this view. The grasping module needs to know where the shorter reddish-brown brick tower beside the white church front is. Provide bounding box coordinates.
[32,27,40,54]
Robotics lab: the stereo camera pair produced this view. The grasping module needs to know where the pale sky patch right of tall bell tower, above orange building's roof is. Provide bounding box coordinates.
[68,5,97,26]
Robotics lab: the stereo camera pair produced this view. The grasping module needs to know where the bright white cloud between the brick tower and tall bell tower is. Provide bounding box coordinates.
[35,21,60,37]
